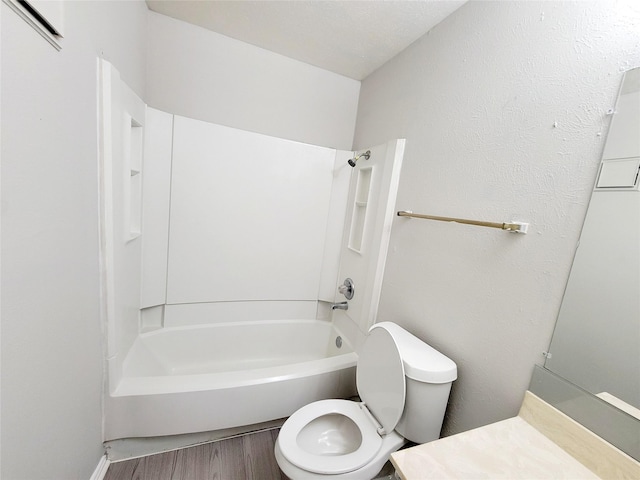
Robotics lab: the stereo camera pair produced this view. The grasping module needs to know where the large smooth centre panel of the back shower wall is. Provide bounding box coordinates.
[167,116,335,303]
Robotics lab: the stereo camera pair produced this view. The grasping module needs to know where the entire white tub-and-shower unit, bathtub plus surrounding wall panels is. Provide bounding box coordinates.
[100,61,399,441]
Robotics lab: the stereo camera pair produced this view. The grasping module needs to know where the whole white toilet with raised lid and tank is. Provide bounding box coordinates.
[275,322,457,480]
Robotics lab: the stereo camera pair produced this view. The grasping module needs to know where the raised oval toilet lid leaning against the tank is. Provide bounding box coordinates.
[356,326,406,434]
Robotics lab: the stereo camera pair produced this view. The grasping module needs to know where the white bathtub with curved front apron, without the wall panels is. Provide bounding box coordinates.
[105,320,357,440]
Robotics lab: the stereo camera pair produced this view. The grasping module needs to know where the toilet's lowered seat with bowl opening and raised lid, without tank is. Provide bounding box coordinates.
[276,325,406,478]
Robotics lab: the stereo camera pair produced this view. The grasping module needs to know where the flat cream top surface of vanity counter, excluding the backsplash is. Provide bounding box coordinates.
[391,417,599,480]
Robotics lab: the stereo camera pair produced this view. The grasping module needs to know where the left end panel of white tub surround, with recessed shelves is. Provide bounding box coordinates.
[98,60,146,394]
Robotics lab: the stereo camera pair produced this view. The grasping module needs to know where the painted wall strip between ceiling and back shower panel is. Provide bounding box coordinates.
[146,12,360,150]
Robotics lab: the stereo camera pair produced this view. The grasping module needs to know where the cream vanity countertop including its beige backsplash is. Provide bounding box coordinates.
[391,392,640,480]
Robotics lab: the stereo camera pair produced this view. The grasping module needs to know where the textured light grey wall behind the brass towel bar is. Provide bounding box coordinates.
[354,2,640,434]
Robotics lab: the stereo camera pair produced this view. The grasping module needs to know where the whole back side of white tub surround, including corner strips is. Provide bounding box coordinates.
[141,108,351,328]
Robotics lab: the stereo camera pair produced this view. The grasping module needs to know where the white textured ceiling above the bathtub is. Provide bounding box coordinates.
[146,0,466,80]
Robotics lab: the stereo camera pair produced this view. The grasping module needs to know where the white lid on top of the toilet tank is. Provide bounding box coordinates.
[369,322,458,383]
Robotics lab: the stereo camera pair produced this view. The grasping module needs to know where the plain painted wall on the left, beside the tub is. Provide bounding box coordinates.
[0,1,147,480]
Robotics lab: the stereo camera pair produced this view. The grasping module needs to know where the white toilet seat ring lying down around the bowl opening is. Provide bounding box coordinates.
[278,400,382,475]
